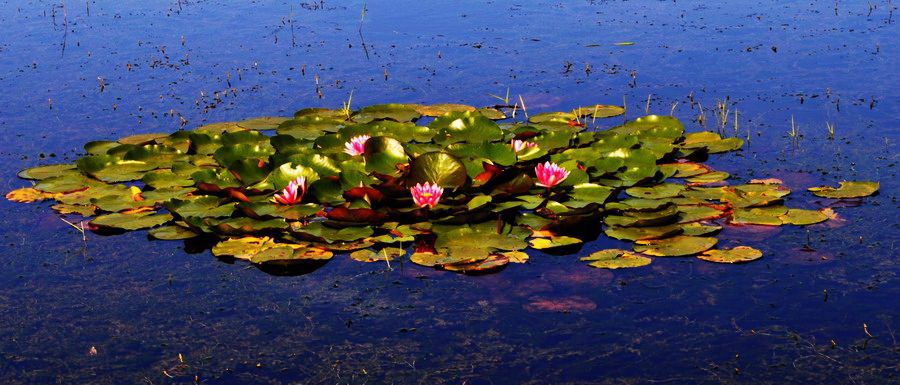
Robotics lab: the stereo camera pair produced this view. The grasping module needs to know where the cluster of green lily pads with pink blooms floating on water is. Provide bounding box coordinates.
[7,104,878,272]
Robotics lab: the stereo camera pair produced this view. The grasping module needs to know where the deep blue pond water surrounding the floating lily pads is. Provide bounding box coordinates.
[0,0,900,384]
